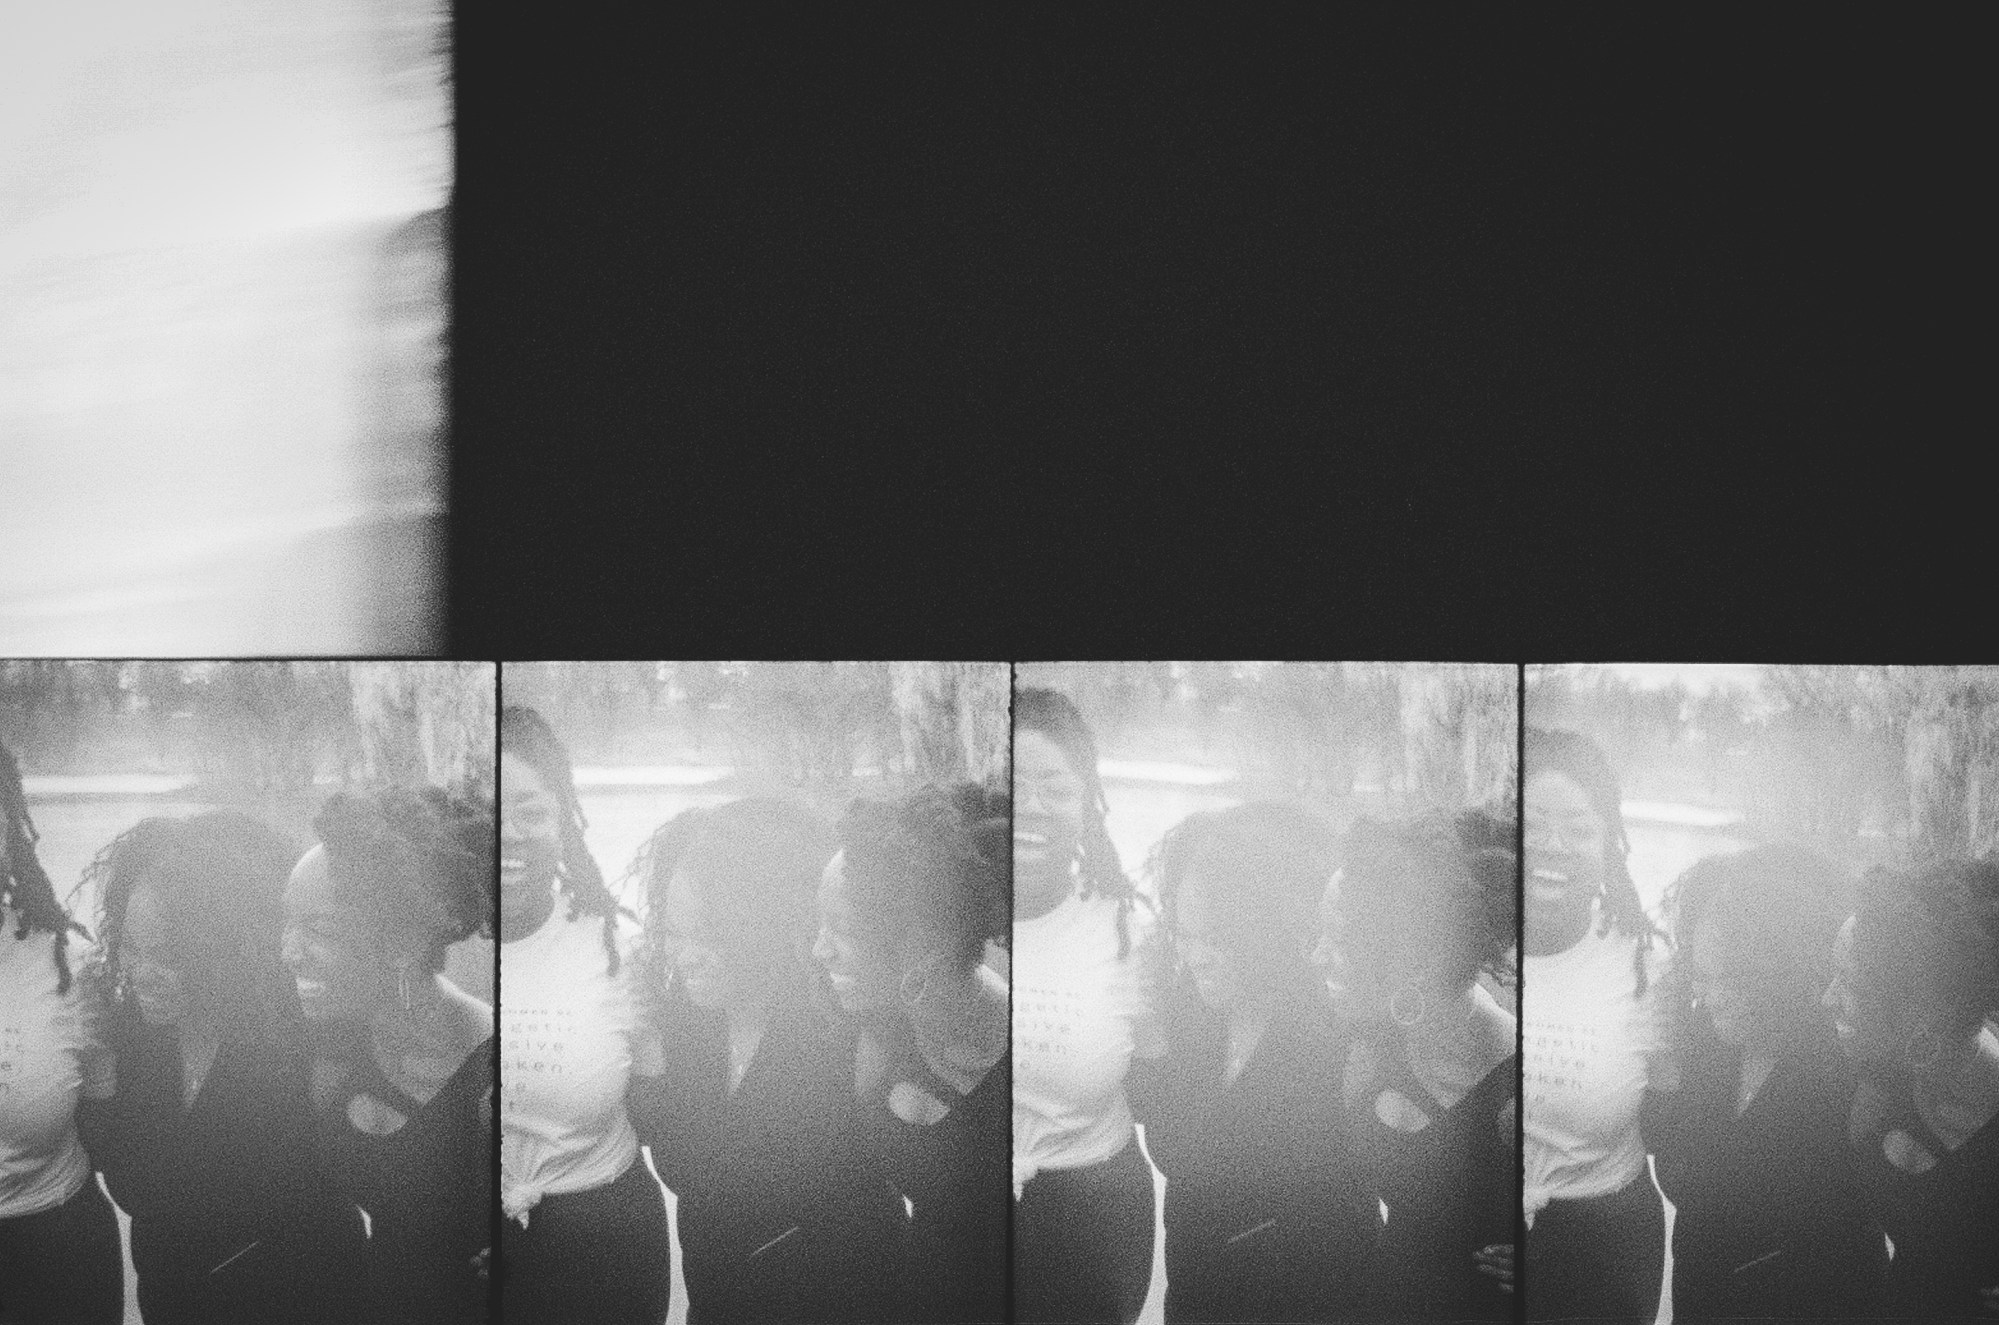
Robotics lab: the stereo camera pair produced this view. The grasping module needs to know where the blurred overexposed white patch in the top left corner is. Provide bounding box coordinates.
[0,0,452,658]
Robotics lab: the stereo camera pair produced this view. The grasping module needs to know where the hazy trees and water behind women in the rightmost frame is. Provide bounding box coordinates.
[1527,663,1999,913]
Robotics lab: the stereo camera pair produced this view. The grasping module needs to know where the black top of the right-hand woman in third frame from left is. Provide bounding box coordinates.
[1353,1049,1519,1321]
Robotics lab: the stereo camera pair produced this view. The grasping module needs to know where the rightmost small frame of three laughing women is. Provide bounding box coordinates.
[1521,663,1999,1325]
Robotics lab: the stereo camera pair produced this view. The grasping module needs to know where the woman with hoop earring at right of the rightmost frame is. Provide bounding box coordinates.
[1825,859,1999,1321]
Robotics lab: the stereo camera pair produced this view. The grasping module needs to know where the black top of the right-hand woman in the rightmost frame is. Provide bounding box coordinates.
[1851,1099,1999,1321]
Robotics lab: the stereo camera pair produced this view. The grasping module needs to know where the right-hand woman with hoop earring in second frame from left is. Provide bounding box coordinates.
[812,783,1011,1321]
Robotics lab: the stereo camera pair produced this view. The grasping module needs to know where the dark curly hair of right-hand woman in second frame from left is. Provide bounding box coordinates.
[840,783,1013,971]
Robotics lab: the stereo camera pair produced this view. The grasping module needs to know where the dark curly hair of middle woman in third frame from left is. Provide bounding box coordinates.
[1145,801,1339,997]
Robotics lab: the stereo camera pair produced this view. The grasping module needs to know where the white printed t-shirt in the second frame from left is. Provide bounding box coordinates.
[500,895,658,1227]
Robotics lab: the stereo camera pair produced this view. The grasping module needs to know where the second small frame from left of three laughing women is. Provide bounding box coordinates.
[500,662,1011,1325]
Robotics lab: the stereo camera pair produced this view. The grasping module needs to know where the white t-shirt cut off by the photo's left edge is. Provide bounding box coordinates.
[0,923,116,1219]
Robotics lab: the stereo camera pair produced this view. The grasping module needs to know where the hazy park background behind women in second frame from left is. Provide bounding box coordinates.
[500,662,1011,1325]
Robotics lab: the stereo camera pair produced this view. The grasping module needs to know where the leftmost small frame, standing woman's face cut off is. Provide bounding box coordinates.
[0,660,498,1325]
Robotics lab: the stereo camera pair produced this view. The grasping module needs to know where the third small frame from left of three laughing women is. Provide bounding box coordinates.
[1013,662,1519,1325]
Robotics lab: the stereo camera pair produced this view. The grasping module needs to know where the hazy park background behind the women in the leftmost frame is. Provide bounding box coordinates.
[0,658,494,1325]
